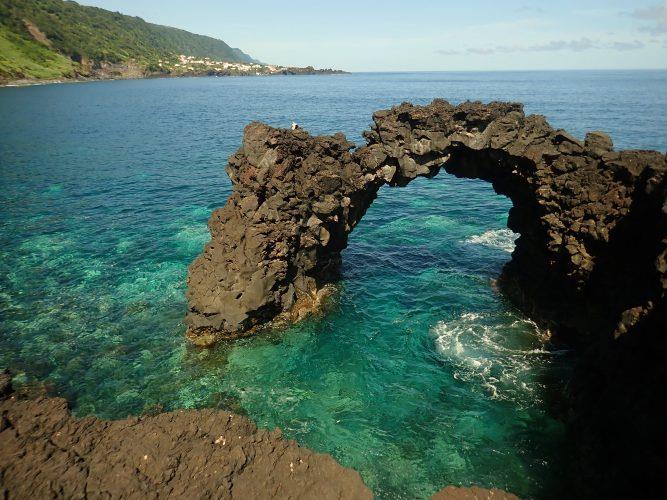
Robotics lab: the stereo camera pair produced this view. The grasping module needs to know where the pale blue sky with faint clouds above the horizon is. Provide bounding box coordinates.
[80,0,667,71]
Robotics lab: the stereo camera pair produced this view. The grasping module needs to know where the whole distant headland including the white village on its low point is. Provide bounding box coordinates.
[0,0,344,85]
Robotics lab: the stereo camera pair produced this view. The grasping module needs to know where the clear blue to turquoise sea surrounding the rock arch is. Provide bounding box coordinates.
[0,72,667,498]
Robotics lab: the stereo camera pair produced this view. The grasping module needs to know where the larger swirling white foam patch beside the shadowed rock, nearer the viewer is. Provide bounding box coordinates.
[432,312,554,405]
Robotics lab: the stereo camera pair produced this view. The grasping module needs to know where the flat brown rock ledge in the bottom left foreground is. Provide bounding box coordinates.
[0,375,372,500]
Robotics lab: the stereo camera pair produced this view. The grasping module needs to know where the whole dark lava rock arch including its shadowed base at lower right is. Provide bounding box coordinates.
[186,100,667,496]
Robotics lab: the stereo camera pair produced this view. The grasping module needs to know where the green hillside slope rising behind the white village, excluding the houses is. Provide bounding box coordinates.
[0,0,254,80]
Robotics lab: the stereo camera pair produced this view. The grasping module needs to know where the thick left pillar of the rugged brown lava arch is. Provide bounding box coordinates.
[186,123,392,344]
